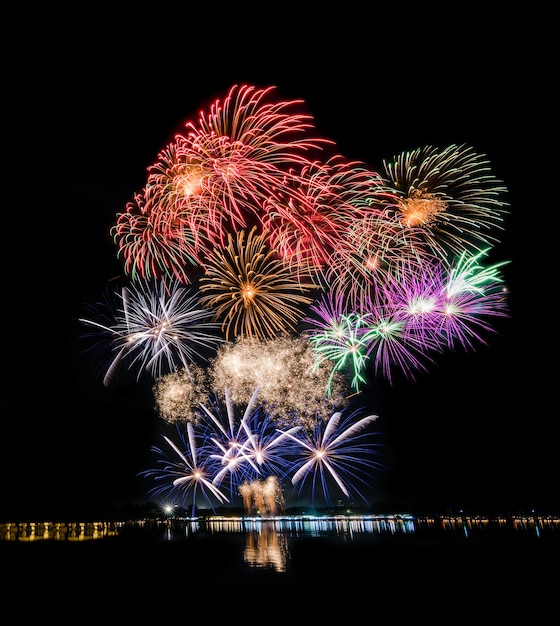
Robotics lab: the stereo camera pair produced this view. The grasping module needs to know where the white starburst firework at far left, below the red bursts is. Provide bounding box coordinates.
[80,281,223,386]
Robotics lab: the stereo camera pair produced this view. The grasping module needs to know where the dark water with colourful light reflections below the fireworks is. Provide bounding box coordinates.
[0,516,560,623]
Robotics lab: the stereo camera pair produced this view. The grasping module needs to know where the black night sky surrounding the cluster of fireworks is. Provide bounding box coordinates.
[1,14,559,518]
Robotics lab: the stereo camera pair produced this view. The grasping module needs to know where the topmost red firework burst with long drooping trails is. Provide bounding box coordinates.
[171,85,332,236]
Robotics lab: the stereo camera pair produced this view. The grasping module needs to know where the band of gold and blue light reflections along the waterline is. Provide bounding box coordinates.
[0,514,560,548]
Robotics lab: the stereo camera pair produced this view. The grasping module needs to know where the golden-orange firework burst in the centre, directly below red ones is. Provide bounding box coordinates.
[200,228,314,340]
